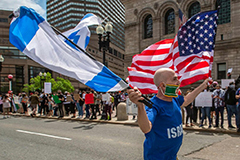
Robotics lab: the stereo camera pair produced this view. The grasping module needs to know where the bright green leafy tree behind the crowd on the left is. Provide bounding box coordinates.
[23,72,74,92]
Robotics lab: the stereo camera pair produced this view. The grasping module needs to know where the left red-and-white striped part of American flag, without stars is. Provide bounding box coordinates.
[128,39,174,94]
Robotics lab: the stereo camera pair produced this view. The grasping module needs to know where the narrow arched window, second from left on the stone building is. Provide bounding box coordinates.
[165,9,175,34]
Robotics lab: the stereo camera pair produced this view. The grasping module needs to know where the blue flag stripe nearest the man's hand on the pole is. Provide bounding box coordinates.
[85,66,122,92]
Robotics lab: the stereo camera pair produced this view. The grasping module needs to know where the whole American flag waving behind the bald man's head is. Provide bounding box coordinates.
[128,11,217,94]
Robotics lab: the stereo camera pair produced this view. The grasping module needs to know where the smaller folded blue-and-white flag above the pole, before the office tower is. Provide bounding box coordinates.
[62,13,101,50]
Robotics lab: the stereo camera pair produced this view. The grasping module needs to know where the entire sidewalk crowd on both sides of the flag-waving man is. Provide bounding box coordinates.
[0,81,240,132]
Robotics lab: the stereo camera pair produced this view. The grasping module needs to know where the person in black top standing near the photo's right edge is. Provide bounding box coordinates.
[224,82,240,129]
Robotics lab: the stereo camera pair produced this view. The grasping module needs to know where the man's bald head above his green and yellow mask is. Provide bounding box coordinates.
[153,68,175,87]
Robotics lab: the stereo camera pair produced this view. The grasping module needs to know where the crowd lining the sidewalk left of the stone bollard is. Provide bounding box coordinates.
[0,89,127,120]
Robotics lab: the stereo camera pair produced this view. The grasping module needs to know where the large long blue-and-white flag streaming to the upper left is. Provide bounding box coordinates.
[9,6,128,92]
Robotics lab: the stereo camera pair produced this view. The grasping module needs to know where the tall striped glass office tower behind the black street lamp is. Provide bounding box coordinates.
[47,0,125,50]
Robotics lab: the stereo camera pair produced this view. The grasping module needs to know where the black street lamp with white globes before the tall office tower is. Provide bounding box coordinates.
[96,22,113,65]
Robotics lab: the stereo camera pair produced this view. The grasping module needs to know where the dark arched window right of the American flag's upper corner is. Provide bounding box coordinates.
[216,0,231,24]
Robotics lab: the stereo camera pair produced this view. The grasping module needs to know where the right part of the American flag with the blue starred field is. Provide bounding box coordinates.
[169,11,218,87]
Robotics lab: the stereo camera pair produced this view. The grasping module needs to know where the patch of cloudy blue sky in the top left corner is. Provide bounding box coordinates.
[0,0,46,18]
